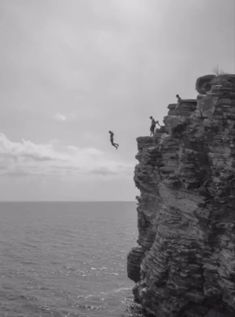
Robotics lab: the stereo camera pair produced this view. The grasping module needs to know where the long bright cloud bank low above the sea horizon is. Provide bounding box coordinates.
[0,133,132,177]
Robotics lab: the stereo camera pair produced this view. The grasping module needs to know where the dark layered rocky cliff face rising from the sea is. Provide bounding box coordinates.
[127,75,235,317]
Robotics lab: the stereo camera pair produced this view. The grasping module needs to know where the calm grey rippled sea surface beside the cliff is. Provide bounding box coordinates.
[0,202,141,317]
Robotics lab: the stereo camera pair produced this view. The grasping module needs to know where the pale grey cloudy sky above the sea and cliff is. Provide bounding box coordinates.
[0,0,235,201]
